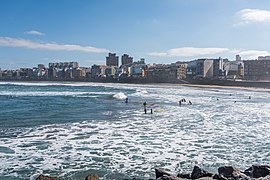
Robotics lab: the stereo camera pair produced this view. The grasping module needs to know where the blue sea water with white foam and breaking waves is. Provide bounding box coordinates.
[0,82,270,180]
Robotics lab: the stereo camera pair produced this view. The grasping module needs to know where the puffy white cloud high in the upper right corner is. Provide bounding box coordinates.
[236,9,270,25]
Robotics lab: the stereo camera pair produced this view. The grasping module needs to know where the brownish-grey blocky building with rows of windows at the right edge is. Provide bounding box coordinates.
[244,58,270,80]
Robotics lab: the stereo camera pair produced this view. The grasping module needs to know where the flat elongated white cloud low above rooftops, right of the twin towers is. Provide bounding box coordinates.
[149,47,229,57]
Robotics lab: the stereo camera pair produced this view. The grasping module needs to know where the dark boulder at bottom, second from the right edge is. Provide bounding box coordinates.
[218,166,247,179]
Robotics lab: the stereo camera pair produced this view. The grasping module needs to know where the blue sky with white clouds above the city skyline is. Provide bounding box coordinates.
[0,0,270,69]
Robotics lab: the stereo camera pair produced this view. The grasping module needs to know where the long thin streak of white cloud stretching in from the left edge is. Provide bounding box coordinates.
[0,37,109,53]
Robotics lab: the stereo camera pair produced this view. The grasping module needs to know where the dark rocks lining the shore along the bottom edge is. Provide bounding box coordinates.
[36,165,270,180]
